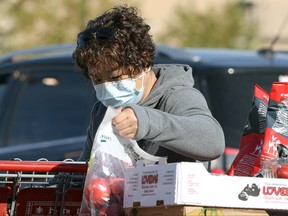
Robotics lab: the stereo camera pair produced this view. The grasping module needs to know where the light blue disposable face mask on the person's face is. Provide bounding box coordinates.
[93,73,145,108]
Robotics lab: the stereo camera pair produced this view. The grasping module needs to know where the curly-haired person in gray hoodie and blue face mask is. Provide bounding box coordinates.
[73,5,225,162]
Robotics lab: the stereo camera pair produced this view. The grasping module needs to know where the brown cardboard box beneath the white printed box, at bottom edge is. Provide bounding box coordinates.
[130,205,269,216]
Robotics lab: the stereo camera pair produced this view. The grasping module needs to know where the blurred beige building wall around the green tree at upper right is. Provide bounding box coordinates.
[130,0,288,49]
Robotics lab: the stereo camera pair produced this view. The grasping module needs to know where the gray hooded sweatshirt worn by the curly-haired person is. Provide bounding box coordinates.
[79,64,225,162]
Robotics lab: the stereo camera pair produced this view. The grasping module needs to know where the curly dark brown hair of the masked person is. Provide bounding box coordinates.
[73,5,155,83]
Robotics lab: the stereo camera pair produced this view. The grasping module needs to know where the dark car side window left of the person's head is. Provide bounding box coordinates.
[8,70,95,145]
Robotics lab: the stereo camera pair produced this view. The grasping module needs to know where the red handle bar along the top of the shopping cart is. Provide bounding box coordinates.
[0,160,88,173]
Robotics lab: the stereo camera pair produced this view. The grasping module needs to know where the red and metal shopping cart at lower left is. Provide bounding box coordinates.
[0,160,87,216]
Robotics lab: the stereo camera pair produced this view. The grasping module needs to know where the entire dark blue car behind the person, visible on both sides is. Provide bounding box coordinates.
[0,44,288,172]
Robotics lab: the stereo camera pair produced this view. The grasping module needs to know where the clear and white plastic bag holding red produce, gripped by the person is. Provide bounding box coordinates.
[80,107,160,216]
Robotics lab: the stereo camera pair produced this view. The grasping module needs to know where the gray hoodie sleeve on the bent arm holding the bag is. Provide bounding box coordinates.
[126,86,225,161]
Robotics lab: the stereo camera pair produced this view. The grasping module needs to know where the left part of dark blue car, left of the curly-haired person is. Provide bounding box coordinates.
[0,45,95,160]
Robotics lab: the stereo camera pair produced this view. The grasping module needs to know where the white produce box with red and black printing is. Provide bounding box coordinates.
[124,161,288,210]
